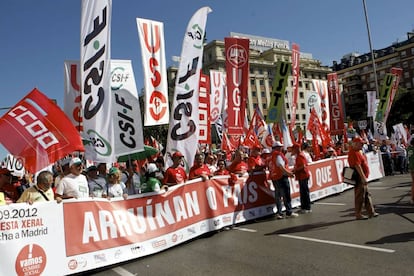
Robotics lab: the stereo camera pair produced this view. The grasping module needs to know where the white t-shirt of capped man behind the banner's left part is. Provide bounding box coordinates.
[56,173,89,198]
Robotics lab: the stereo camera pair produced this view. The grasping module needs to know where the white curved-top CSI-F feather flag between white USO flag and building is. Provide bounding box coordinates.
[166,7,211,166]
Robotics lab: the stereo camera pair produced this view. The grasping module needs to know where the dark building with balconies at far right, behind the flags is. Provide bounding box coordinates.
[332,30,414,121]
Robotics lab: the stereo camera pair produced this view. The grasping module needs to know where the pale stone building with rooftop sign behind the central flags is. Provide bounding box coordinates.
[168,33,332,129]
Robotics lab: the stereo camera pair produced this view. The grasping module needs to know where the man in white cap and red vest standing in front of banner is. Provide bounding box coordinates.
[269,141,298,219]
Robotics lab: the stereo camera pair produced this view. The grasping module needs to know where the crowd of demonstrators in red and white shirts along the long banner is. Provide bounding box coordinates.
[0,133,414,212]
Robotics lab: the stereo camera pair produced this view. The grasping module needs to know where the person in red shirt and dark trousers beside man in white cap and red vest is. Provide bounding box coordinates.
[292,143,312,213]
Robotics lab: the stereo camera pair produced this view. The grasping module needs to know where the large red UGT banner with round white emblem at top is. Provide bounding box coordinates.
[224,37,249,135]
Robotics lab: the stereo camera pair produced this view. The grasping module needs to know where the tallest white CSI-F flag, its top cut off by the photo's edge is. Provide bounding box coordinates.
[80,0,116,163]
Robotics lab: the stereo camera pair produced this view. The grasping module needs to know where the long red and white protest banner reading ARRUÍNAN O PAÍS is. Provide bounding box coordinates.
[0,153,383,275]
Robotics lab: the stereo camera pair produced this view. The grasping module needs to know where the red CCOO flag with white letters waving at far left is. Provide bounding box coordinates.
[0,89,84,173]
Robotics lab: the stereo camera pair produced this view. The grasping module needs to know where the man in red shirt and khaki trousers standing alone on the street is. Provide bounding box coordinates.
[348,136,378,220]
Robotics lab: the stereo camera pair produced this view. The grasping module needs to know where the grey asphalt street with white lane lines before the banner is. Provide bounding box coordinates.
[83,174,414,276]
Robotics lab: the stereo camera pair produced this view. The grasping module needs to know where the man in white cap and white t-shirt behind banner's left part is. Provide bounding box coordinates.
[56,157,89,200]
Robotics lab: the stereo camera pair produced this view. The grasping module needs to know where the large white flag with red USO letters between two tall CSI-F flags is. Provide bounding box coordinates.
[137,18,170,126]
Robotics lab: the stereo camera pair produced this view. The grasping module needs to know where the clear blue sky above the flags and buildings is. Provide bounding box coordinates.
[0,0,414,158]
